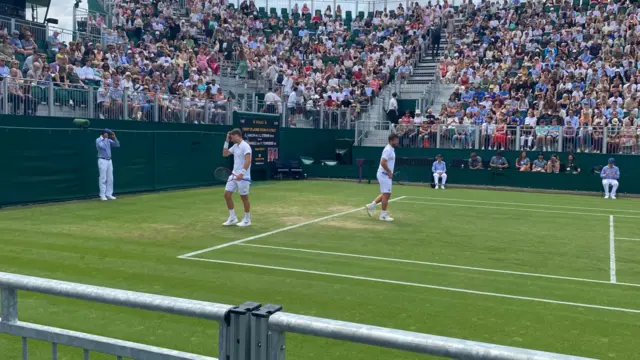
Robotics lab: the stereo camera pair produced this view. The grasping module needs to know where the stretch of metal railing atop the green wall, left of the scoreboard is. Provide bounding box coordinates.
[0,78,237,125]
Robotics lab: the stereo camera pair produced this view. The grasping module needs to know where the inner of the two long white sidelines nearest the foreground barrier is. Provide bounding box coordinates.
[238,244,640,287]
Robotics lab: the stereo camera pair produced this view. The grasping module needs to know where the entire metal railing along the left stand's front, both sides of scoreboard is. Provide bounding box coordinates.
[0,78,379,129]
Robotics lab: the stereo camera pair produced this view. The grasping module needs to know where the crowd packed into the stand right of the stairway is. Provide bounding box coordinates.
[404,0,640,153]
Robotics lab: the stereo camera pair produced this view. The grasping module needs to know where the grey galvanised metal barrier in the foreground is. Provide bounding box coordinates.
[0,273,586,360]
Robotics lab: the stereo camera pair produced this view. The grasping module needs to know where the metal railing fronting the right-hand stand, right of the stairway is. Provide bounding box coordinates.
[380,123,640,155]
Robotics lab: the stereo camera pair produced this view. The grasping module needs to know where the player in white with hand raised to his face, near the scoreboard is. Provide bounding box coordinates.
[222,129,251,226]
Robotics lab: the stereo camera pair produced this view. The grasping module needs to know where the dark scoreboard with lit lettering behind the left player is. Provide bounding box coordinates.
[238,113,280,166]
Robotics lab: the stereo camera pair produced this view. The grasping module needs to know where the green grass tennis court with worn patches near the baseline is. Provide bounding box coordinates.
[0,181,640,360]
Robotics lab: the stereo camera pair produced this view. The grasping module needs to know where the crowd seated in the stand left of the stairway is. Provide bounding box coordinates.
[0,0,448,124]
